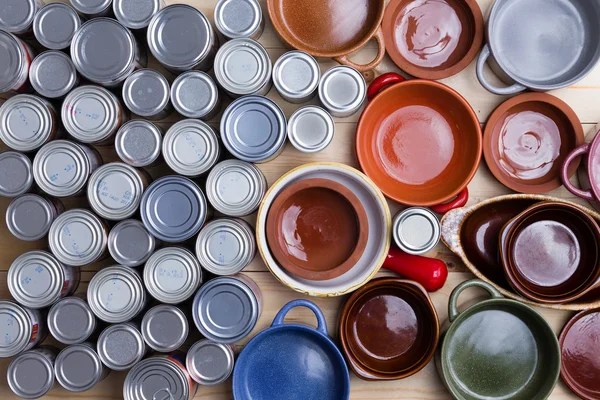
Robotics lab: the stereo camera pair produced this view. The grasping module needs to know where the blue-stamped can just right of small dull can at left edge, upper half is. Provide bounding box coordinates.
[33,140,102,197]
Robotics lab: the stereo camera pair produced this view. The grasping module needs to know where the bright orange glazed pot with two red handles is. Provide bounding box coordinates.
[356,73,482,212]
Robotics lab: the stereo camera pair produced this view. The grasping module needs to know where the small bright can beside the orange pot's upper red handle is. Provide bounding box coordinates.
[319,65,367,118]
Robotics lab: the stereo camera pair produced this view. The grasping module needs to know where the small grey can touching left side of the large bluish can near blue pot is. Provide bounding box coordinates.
[142,304,189,353]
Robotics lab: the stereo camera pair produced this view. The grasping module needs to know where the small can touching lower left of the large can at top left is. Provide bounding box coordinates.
[29,50,79,99]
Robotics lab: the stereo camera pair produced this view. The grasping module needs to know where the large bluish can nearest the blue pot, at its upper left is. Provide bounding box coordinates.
[192,277,260,344]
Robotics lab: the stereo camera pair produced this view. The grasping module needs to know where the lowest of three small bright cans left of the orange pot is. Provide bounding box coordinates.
[288,106,335,153]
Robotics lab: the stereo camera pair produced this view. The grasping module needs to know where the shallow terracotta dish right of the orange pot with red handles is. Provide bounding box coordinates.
[483,93,584,193]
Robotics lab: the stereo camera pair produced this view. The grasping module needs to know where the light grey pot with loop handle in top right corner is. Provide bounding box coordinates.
[477,0,600,95]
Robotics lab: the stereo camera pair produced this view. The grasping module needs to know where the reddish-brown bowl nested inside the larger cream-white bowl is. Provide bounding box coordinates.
[266,178,369,280]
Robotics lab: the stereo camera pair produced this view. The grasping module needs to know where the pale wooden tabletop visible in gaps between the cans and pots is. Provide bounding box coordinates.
[0,0,600,400]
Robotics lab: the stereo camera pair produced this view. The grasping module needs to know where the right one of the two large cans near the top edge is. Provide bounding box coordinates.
[147,4,219,73]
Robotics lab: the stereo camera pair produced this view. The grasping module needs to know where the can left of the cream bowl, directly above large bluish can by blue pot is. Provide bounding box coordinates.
[196,218,256,275]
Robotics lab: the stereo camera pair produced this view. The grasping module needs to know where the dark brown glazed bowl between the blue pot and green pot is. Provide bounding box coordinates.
[339,278,440,380]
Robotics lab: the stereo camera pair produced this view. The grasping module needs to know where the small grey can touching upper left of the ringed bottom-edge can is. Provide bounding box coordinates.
[97,323,146,371]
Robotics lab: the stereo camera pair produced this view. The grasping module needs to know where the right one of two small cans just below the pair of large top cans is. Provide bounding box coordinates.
[171,71,221,121]
